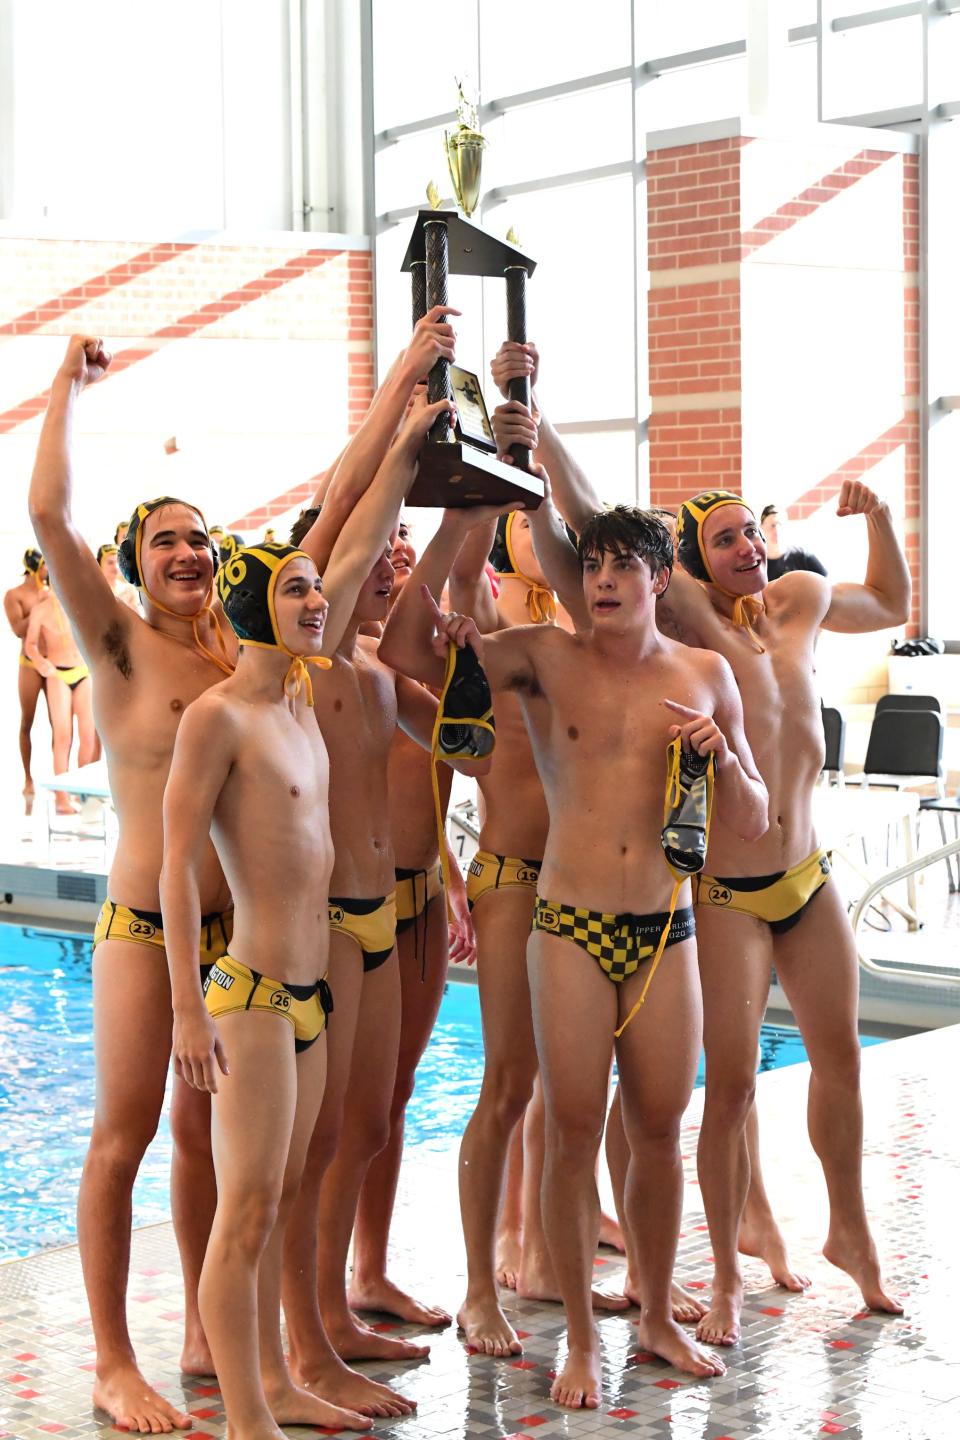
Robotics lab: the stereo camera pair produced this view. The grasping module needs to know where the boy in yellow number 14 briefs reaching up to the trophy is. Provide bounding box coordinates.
[277,402,482,1378]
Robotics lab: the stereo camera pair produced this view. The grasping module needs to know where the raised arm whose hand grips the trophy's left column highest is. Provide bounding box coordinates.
[296,305,459,575]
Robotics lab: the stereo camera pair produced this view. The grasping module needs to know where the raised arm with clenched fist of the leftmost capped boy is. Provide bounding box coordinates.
[29,336,130,662]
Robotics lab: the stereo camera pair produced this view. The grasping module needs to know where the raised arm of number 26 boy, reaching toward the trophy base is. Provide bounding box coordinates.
[312,400,452,655]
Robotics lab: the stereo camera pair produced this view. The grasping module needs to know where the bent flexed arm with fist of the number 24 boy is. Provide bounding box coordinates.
[823,480,910,635]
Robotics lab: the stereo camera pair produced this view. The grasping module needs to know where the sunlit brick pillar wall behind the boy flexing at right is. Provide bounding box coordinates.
[648,127,920,648]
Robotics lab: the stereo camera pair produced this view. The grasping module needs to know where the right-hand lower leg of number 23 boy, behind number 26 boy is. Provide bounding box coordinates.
[170,1076,217,1375]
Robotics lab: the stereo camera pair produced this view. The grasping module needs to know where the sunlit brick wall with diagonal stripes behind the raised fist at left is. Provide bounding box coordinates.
[0,235,373,550]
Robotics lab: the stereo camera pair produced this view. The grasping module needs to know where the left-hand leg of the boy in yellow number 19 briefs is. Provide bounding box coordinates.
[456,888,537,1355]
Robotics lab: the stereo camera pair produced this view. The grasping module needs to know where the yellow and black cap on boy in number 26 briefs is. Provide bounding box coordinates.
[217,544,332,706]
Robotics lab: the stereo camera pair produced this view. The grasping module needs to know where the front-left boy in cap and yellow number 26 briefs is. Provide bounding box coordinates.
[160,546,371,1440]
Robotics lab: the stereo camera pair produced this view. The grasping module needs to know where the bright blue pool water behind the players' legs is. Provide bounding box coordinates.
[0,923,875,1261]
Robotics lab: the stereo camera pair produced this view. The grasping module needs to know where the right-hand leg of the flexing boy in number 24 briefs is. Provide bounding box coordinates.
[774,880,902,1315]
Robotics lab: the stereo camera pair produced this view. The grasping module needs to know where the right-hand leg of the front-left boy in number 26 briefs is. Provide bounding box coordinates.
[258,1032,371,1430]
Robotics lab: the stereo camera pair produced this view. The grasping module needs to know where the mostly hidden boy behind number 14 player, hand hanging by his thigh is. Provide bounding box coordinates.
[347,516,476,1326]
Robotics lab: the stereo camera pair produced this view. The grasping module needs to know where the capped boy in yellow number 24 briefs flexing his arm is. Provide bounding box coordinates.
[665,481,910,1345]
